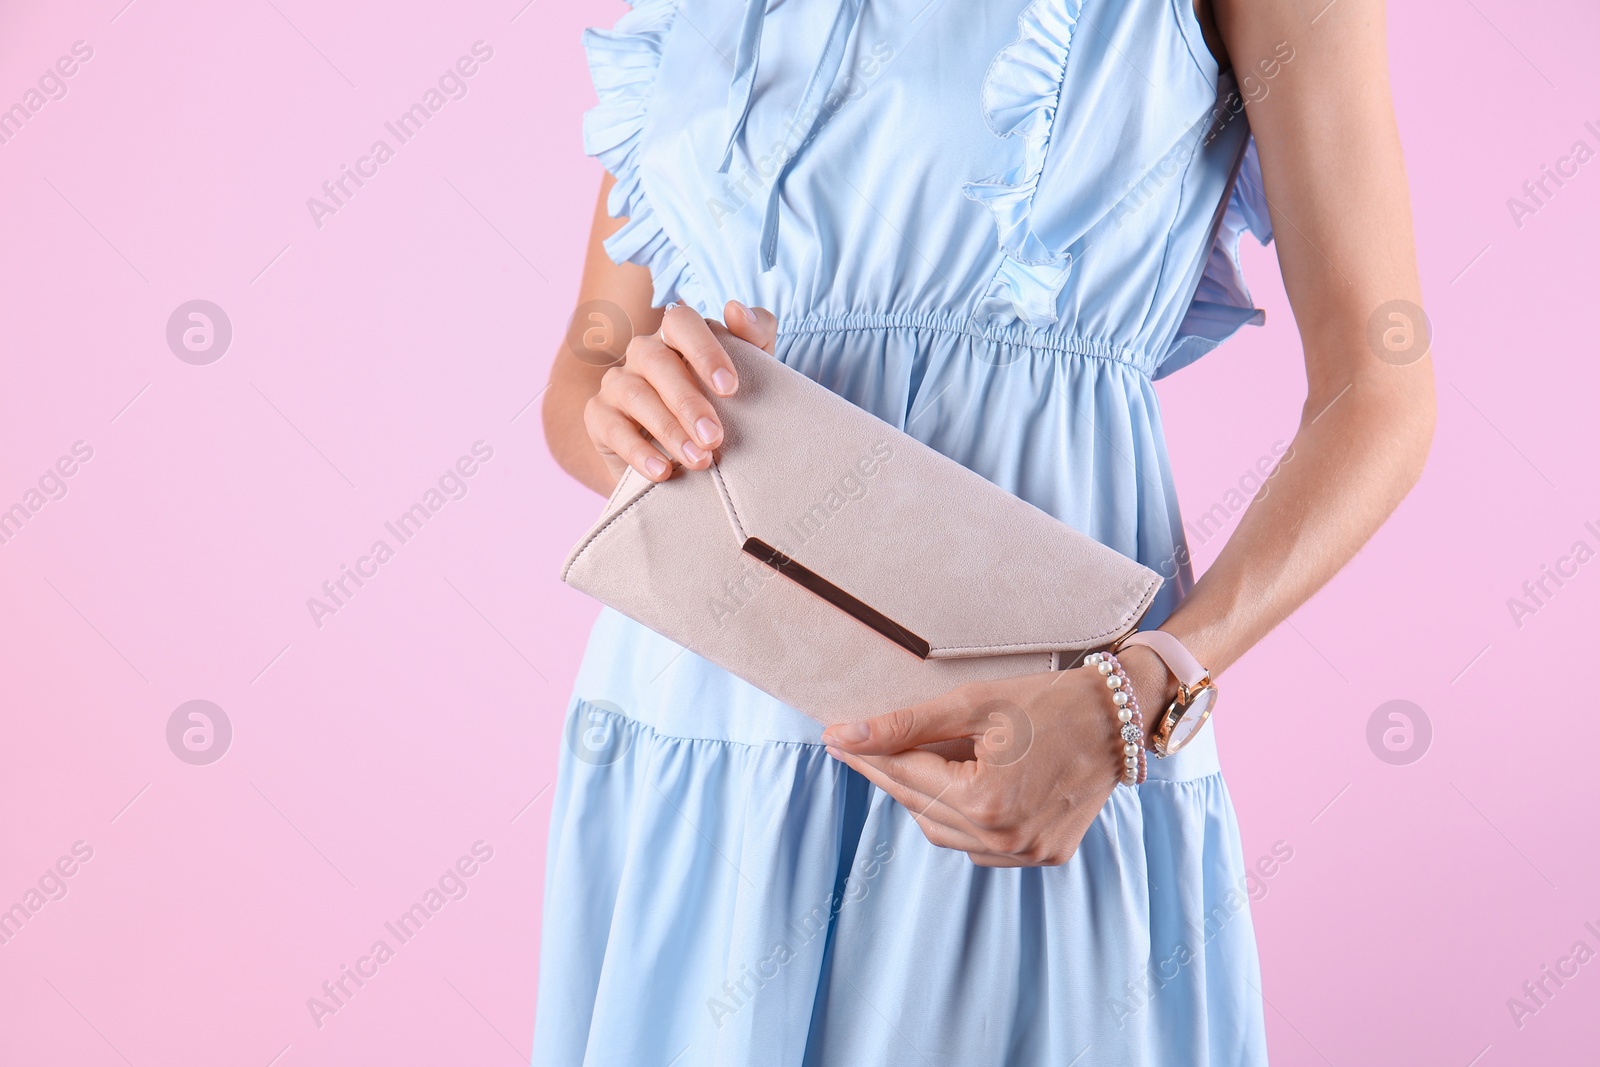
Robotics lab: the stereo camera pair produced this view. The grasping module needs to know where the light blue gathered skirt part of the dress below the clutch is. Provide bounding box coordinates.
[533,609,1266,1067]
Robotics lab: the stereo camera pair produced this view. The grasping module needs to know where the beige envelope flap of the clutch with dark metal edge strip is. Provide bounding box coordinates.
[684,338,1162,659]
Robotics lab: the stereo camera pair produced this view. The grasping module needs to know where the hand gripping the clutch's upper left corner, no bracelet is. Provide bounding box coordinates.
[584,301,778,482]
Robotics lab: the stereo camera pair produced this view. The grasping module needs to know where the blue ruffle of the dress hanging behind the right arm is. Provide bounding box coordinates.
[1154,138,1272,378]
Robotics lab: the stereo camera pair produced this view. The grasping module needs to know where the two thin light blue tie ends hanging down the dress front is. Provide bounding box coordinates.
[717,0,864,272]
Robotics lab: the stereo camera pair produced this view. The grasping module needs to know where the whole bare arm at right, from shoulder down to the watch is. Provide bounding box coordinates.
[1162,0,1434,684]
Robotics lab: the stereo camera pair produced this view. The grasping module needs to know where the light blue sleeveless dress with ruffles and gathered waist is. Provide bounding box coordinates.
[533,0,1270,1067]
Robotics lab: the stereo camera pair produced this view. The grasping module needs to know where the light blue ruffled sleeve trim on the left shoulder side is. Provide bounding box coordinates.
[584,0,701,307]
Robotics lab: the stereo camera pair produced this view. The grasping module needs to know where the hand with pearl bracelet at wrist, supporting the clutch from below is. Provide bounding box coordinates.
[822,648,1170,867]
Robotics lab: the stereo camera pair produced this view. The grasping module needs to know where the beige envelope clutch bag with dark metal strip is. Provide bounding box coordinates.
[562,331,1162,723]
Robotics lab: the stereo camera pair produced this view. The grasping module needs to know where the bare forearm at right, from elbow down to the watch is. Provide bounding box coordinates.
[1162,360,1434,675]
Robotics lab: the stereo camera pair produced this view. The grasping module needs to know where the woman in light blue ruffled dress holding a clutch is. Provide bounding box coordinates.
[533,0,1434,1067]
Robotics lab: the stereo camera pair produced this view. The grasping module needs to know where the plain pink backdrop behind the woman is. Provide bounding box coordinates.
[0,0,1600,1067]
